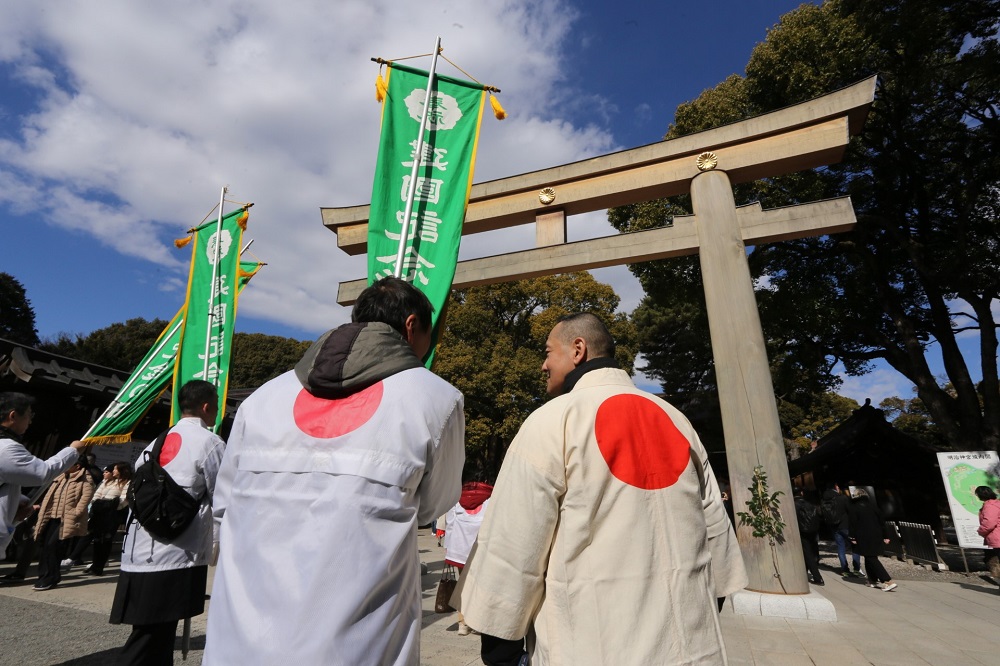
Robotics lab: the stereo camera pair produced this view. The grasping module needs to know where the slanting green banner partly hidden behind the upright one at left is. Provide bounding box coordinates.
[82,261,261,444]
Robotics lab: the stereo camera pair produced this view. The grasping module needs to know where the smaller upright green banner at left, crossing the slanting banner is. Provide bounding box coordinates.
[170,208,247,427]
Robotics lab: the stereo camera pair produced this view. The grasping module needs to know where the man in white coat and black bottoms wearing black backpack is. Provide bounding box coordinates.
[110,379,226,666]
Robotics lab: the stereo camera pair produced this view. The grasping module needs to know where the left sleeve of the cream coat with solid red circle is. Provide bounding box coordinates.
[452,412,566,640]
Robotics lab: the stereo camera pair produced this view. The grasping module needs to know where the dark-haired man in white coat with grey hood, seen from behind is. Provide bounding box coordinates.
[204,278,465,666]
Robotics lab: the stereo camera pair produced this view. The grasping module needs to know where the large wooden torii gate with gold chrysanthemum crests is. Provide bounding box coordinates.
[321,77,876,594]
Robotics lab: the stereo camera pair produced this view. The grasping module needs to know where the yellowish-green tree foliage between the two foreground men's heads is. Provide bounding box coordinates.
[434,273,637,481]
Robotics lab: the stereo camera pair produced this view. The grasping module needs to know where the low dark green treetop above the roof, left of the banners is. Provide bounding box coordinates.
[40,317,169,372]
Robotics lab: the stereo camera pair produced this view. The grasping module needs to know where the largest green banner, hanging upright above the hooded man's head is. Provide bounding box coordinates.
[368,63,486,358]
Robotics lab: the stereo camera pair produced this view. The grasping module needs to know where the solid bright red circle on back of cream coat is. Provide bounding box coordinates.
[594,393,691,490]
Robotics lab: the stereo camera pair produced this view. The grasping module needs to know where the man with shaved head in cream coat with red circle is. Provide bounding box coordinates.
[452,314,747,666]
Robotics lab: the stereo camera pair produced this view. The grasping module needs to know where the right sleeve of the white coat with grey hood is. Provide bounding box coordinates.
[412,394,465,525]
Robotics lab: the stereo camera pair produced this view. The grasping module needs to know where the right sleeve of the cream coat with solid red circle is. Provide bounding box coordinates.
[691,435,749,597]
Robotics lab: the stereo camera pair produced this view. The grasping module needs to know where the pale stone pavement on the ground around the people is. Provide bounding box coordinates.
[0,530,1000,666]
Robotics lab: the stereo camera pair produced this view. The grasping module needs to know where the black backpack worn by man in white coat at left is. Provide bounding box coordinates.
[128,430,201,541]
